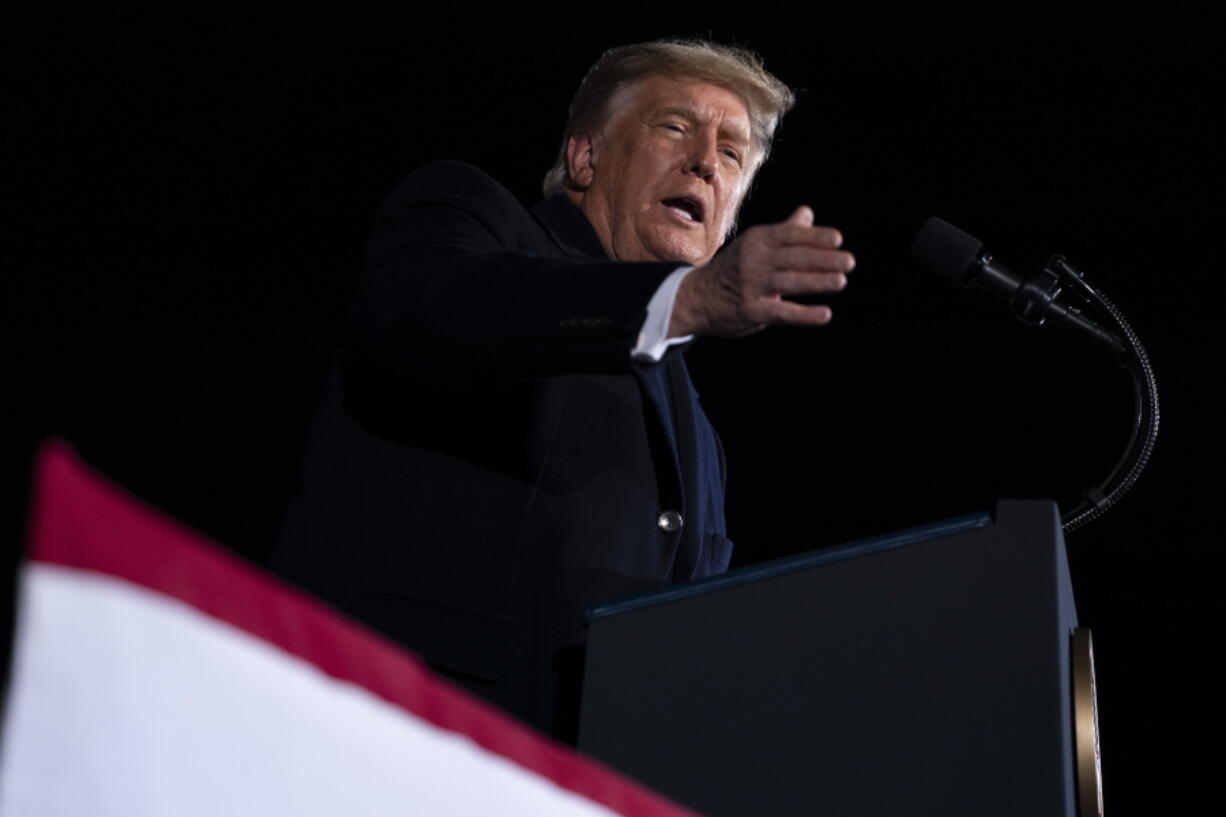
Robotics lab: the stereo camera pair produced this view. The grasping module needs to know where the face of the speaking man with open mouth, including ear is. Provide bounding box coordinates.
[568,76,756,265]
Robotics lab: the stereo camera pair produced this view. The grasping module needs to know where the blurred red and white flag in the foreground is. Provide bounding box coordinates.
[0,443,706,817]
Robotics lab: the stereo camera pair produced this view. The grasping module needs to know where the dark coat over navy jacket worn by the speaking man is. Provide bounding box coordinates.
[273,162,732,736]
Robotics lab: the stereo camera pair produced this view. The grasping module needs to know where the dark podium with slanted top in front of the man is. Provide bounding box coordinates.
[579,501,1101,817]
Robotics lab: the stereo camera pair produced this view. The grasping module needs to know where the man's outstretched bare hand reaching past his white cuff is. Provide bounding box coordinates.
[668,206,856,337]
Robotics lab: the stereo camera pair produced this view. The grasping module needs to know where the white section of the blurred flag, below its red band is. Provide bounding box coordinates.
[0,563,613,817]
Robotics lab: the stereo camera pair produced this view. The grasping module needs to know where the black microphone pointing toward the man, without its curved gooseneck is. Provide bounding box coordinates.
[911,216,1124,352]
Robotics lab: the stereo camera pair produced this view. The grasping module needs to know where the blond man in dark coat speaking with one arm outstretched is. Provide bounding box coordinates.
[276,42,853,737]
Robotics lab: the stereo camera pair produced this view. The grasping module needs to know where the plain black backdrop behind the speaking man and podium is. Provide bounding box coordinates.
[2,5,1224,815]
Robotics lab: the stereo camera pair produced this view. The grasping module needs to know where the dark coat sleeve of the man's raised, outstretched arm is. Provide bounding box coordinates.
[343,162,677,389]
